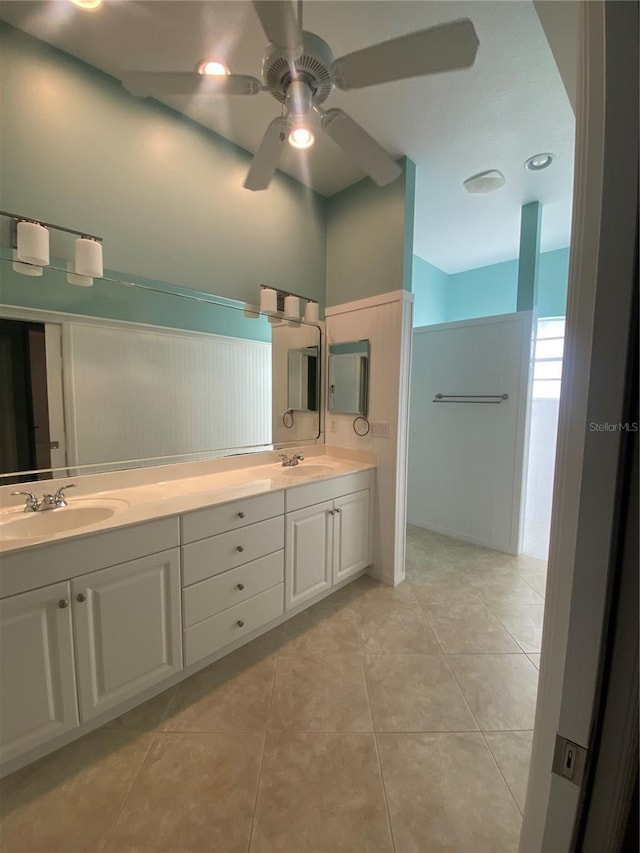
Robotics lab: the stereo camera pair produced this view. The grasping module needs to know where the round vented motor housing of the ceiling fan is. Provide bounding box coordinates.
[262,31,333,105]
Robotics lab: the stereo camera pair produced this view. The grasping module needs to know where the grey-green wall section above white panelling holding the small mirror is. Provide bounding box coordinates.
[327,159,415,305]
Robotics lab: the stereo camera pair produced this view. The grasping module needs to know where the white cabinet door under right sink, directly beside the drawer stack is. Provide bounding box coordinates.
[285,501,333,610]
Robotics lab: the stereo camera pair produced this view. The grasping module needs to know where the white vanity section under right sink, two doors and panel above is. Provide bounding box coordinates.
[285,471,371,610]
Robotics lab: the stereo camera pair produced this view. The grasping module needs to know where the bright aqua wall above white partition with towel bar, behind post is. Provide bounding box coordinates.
[412,248,569,326]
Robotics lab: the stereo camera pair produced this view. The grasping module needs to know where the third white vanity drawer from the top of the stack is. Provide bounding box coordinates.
[182,551,284,628]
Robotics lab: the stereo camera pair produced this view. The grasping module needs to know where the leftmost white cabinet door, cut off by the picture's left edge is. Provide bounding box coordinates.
[0,582,78,762]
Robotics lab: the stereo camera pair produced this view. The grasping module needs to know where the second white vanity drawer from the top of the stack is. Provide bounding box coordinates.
[182,515,284,586]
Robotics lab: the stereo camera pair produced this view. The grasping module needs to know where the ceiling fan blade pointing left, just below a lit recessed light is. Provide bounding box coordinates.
[122,71,263,97]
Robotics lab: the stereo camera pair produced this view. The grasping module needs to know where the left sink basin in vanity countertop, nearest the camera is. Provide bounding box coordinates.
[0,500,129,541]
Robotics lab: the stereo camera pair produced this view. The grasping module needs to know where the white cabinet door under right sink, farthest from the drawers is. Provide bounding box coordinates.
[333,489,370,583]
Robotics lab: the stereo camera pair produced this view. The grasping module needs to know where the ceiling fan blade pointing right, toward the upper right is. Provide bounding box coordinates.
[331,18,479,89]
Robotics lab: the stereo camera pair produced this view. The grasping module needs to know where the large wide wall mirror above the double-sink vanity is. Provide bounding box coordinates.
[0,258,321,485]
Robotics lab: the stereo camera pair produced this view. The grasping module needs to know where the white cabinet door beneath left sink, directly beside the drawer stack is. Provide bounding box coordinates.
[71,548,182,721]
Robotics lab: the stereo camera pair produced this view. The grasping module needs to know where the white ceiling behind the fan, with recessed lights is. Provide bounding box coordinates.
[0,0,577,273]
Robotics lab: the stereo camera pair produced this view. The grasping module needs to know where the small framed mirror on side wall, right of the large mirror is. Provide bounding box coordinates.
[328,340,369,415]
